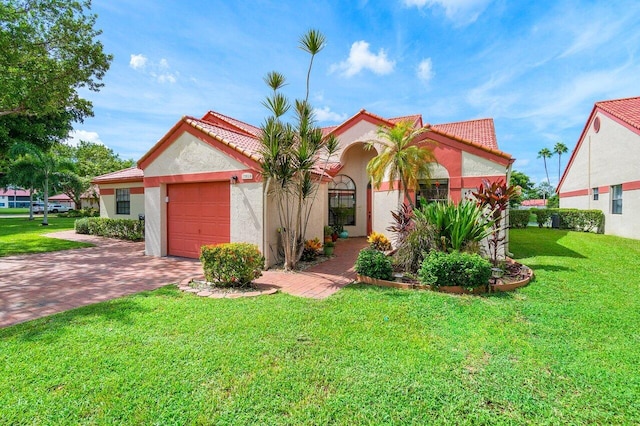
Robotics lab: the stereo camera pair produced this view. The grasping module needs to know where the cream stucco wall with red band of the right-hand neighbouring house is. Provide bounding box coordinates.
[560,111,640,239]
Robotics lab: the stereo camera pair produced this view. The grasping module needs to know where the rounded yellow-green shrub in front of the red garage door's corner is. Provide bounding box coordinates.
[200,243,264,287]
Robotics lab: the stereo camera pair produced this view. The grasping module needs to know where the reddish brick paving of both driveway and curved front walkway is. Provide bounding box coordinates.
[0,231,366,327]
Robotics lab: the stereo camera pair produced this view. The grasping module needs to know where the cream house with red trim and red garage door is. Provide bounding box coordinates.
[93,110,514,265]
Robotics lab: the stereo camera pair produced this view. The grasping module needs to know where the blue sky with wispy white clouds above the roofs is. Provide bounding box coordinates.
[74,0,640,184]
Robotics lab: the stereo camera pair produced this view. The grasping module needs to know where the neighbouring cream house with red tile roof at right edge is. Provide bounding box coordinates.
[557,97,640,239]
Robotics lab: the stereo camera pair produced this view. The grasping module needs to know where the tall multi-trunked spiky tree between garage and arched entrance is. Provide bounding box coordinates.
[261,30,338,270]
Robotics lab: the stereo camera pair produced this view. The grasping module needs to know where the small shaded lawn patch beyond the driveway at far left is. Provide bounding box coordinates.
[0,215,91,257]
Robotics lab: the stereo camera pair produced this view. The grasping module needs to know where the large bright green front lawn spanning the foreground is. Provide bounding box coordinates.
[0,228,640,425]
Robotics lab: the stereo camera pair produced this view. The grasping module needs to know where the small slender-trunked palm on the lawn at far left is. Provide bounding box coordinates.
[10,142,74,226]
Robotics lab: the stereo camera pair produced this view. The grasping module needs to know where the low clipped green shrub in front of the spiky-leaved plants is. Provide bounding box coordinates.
[418,251,491,289]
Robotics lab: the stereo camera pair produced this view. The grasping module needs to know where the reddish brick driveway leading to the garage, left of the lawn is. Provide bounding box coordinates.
[0,231,202,327]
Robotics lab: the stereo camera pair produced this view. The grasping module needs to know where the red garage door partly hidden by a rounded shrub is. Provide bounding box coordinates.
[167,181,230,258]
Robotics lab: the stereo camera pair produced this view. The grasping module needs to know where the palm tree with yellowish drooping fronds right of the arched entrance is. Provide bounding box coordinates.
[365,121,436,207]
